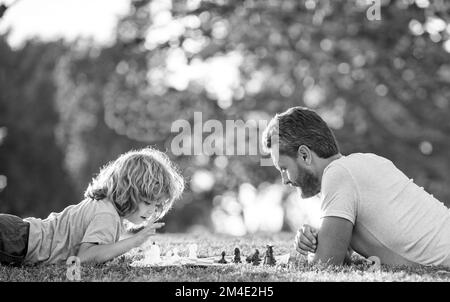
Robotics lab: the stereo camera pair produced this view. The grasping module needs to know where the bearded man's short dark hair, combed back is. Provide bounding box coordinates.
[263,107,339,158]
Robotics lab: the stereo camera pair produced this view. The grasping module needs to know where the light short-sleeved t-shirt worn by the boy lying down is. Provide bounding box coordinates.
[24,199,123,263]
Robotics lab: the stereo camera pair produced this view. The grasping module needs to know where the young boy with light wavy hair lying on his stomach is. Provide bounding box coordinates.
[0,148,184,264]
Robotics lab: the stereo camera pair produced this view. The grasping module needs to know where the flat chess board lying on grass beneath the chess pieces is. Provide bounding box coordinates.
[131,254,290,267]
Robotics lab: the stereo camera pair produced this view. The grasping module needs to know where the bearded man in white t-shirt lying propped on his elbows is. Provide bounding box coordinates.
[263,107,450,266]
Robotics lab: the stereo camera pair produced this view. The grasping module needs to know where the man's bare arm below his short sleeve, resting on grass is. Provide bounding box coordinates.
[314,216,353,265]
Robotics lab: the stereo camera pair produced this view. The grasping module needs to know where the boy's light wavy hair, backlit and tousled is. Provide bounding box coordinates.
[84,147,184,219]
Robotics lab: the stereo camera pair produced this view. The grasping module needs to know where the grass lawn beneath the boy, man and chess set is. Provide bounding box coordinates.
[0,233,450,282]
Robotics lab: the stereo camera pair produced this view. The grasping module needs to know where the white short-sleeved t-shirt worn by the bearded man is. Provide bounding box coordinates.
[321,153,450,266]
